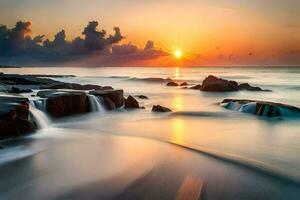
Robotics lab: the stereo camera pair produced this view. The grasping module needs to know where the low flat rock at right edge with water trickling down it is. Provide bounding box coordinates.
[222,99,300,117]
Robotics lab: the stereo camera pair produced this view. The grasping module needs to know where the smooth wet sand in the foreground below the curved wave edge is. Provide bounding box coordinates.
[0,130,300,200]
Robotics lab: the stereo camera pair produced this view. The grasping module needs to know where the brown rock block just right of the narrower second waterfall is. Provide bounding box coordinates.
[90,89,124,110]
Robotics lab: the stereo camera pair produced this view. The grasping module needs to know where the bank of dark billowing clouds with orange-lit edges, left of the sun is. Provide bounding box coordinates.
[0,21,166,63]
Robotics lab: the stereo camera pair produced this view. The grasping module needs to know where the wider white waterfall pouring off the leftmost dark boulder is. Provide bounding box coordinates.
[29,100,51,129]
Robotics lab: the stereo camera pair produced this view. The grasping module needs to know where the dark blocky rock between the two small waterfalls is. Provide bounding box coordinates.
[46,92,90,117]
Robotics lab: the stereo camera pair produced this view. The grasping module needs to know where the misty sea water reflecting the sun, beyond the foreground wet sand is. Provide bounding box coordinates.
[0,67,300,198]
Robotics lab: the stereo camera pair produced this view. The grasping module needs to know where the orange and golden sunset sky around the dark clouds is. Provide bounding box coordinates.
[0,0,300,66]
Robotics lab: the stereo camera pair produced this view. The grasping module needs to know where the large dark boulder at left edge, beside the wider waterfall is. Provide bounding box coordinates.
[0,96,36,139]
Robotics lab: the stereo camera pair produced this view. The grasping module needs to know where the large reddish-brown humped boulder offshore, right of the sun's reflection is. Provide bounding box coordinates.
[201,75,239,92]
